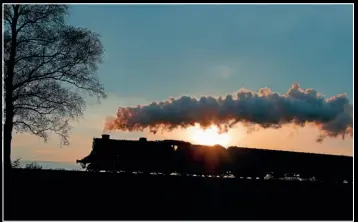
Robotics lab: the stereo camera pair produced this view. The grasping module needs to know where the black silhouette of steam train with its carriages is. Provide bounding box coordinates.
[77,134,353,182]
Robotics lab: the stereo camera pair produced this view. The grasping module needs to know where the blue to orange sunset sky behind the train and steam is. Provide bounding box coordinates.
[12,4,353,162]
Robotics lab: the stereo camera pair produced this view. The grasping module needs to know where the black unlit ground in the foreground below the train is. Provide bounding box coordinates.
[5,170,353,220]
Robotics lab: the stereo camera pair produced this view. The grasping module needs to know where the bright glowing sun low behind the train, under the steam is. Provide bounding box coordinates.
[188,125,230,147]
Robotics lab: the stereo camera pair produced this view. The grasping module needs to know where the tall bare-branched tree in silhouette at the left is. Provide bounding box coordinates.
[3,4,106,172]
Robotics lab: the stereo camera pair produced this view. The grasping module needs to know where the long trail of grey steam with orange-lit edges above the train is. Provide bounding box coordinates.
[105,84,353,142]
